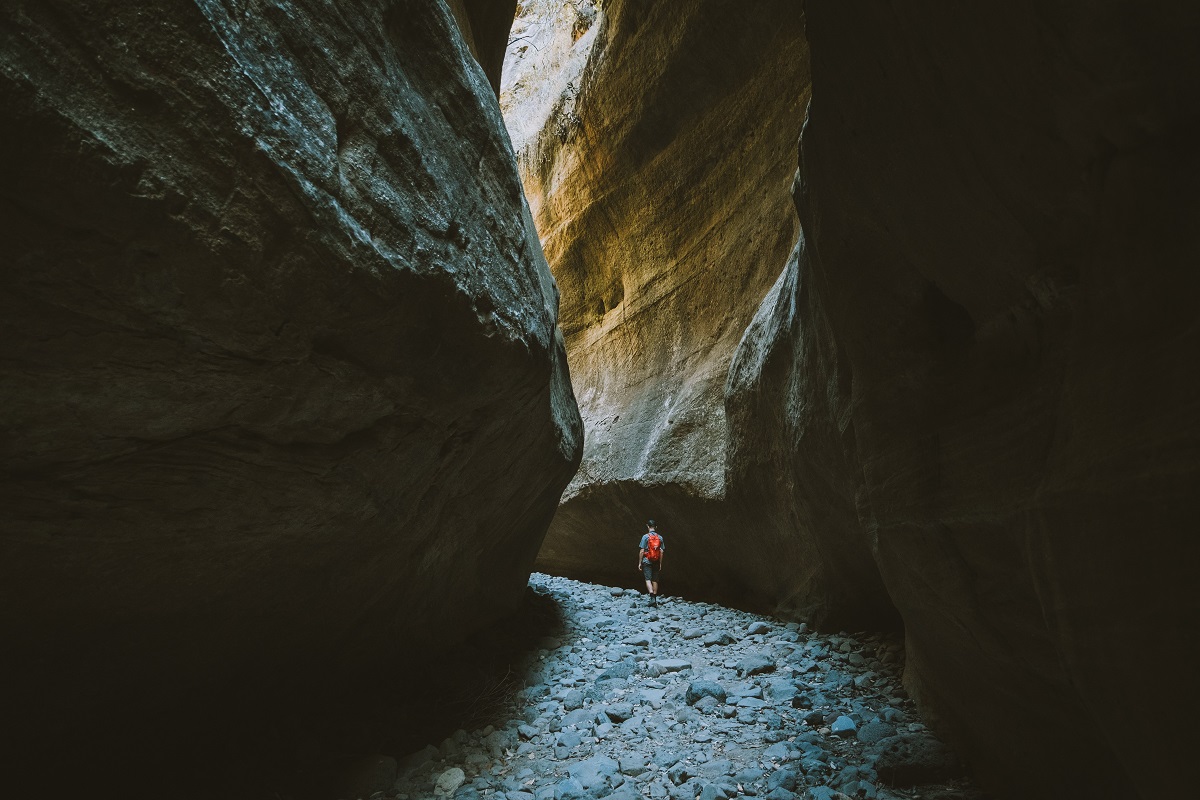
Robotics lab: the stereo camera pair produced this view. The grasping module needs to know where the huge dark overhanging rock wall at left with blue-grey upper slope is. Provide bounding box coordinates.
[0,0,582,738]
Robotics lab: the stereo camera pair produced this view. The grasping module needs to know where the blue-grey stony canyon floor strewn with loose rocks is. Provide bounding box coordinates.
[369,573,982,800]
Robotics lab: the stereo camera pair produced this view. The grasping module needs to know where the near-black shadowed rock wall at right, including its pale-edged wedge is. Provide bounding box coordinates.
[728,0,1200,798]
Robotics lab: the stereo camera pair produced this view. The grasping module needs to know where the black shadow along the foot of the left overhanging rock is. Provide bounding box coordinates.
[5,589,563,800]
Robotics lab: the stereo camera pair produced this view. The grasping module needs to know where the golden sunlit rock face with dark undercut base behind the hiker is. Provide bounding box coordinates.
[502,1,808,597]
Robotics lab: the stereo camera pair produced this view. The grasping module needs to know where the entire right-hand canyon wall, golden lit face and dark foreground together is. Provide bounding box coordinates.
[517,0,1200,798]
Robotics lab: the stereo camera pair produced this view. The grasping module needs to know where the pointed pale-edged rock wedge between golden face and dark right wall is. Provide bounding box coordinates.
[726,235,896,630]
